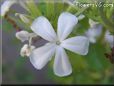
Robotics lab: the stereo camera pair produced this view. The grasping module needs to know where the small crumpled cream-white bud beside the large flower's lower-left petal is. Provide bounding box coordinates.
[20,44,35,57]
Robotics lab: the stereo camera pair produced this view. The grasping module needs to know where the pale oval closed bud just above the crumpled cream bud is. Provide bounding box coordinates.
[16,30,37,42]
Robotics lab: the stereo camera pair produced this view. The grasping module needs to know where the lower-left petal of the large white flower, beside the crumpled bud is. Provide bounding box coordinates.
[30,43,55,70]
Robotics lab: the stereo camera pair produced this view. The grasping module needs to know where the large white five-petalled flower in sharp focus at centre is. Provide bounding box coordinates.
[30,12,89,77]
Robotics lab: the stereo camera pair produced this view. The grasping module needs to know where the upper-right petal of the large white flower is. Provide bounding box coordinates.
[57,12,78,41]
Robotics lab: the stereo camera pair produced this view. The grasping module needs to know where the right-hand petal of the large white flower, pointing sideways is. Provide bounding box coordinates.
[61,36,89,55]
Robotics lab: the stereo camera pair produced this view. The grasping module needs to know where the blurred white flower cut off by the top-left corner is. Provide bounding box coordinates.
[1,0,16,17]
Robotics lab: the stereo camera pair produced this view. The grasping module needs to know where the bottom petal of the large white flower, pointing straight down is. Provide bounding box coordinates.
[53,46,72,77]
